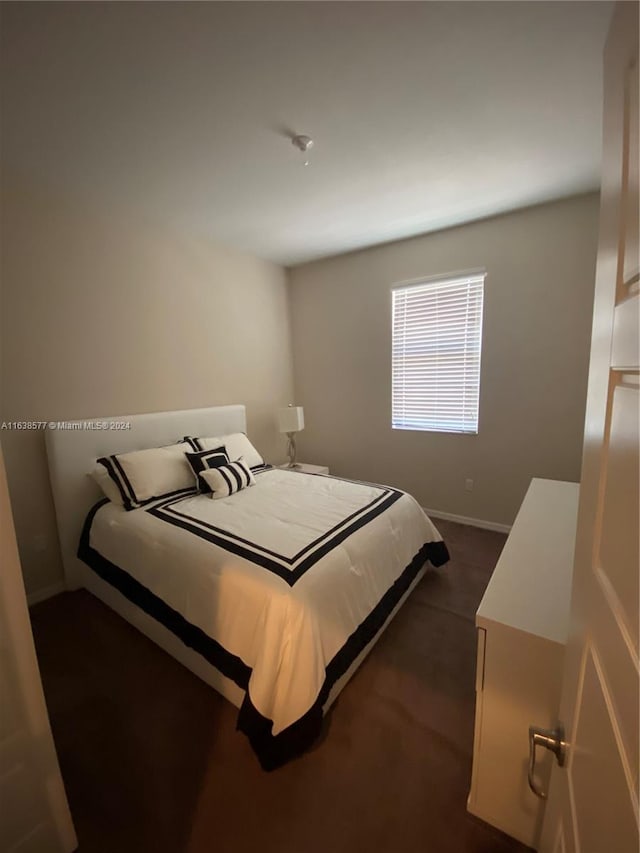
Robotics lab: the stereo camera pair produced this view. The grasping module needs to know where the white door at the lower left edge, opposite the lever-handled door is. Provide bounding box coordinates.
[0,451,77,853]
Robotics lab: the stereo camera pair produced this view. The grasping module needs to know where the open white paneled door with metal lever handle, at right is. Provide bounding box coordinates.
[540,2,640,853]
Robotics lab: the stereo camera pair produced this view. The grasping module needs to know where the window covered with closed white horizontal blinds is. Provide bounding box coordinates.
[391,272,485,433]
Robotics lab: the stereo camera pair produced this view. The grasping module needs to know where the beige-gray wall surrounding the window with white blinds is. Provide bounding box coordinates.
[290,194,598,524]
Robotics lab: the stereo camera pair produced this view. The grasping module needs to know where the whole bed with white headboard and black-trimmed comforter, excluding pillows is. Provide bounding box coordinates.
[47,406,448,770]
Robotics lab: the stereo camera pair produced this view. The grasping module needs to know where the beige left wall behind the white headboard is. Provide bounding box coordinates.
[0,175,293,594]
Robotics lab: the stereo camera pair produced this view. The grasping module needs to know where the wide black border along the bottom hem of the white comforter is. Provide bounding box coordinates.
[78,499,449,770]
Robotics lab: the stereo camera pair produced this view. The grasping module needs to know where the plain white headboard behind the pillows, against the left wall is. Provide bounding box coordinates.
[46,406,247,589]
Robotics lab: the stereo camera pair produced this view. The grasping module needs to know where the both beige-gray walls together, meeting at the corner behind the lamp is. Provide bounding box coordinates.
[0,186,598,594]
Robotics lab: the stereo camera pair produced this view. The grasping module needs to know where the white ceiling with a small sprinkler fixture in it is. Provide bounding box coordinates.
[1,0,612,265]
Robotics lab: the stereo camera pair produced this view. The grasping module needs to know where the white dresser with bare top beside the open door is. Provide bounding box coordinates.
[467,479,579,848]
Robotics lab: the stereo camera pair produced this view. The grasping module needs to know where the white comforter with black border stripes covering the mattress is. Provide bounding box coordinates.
[78,469,448,770]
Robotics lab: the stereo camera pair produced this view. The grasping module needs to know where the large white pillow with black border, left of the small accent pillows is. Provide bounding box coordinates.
[98,442,195,510]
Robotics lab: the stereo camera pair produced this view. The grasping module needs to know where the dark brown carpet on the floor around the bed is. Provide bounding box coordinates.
[31,521,528,853]
